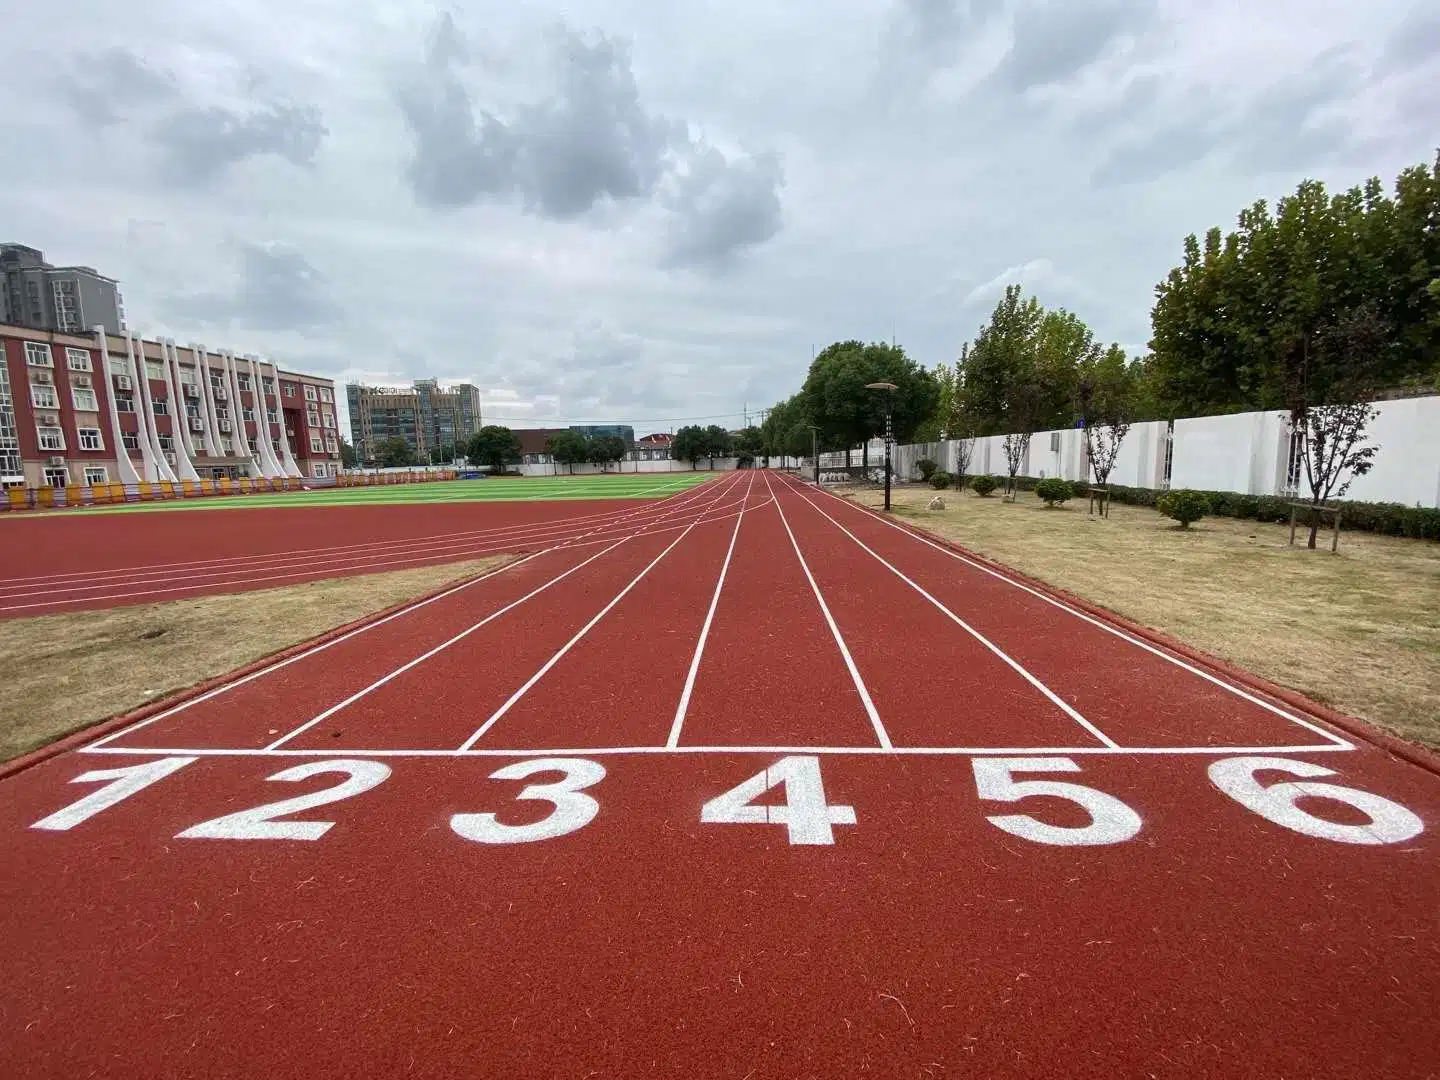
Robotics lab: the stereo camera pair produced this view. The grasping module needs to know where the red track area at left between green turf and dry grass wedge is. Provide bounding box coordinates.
[0,500,691,618]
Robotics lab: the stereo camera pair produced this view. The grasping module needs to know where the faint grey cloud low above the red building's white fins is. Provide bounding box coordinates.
[168,242,340,331]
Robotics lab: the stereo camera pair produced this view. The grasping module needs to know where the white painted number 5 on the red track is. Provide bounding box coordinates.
[973,757,1140,847]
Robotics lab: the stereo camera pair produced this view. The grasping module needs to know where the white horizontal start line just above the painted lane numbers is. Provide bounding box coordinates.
[84,743,1346,759]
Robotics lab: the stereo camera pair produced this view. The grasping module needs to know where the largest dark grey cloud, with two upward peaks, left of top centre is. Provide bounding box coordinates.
[397,14,684,220]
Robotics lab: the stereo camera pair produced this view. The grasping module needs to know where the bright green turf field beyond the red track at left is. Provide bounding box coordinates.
[40,472,714,517]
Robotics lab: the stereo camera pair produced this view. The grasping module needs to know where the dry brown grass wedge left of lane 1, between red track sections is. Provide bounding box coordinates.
[0,556,511,760]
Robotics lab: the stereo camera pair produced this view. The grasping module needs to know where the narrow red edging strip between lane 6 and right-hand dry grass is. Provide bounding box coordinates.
[801,481,1440,776]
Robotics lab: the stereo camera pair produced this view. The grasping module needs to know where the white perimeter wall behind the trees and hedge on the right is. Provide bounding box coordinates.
[821,396,1440,507]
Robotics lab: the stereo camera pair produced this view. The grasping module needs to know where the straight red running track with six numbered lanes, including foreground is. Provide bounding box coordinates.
[0,474,1440,1080]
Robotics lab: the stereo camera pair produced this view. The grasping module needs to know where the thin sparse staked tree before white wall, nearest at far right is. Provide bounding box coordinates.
[1286,304,1388,550]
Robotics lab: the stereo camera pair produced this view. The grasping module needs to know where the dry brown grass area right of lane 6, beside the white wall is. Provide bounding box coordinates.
[851,487,1440,746]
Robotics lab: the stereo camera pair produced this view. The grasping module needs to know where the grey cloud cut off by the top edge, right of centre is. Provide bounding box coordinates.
[995,0,1155,89]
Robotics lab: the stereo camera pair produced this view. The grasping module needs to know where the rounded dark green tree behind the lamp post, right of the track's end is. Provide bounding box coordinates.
[799,341,940,465]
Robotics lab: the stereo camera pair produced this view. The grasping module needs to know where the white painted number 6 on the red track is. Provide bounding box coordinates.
[1210,757,1424,844]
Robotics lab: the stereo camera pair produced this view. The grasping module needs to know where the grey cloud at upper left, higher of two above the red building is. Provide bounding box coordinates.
[154,104,328,184]
